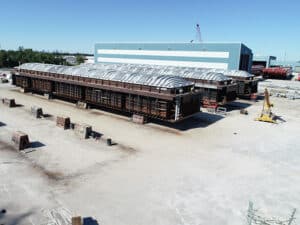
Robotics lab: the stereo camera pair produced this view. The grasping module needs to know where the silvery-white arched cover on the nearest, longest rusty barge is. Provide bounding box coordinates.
[19,63,193,88]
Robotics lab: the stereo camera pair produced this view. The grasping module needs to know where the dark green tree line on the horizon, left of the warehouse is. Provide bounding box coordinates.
[0,47,90,68]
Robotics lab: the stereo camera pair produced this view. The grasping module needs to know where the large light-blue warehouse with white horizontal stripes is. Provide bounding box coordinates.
[94,43,253,72]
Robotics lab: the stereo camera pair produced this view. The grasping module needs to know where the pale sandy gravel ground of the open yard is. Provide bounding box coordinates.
[0,84,300,225]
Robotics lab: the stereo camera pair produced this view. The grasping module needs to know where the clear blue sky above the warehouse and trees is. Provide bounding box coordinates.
[0,0,300,60]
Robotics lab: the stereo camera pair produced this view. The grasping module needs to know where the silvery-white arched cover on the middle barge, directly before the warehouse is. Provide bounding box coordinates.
[91,63,231,81]
